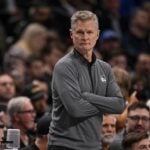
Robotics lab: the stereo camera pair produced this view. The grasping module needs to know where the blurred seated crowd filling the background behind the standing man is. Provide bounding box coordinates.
[0,0,150,150]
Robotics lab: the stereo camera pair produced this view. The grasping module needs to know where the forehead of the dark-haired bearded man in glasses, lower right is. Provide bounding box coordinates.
[129,108,150,117]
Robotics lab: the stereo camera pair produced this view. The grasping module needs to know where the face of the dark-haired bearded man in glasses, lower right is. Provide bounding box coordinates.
[126,108,150,132]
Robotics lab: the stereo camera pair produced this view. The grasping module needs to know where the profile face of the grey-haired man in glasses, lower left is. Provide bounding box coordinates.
[16,101,36,131]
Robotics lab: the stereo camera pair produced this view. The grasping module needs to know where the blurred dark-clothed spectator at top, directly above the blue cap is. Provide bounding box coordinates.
[96,0,128,39]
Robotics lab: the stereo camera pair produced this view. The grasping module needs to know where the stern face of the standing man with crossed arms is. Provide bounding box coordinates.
[70,20,99,54]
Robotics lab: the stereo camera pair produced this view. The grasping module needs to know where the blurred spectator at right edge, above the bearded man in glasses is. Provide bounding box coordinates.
[132,53,150,101]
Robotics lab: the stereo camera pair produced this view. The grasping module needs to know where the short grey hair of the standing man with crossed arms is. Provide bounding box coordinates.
[71,10,99,29]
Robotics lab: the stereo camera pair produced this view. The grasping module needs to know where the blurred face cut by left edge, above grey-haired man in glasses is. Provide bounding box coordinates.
[0,74,16,102]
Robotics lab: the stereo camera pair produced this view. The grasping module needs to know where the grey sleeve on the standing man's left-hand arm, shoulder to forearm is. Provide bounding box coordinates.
[52,63,99,118]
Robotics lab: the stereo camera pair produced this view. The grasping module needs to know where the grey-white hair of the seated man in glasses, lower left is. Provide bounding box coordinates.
[7,96,30,122]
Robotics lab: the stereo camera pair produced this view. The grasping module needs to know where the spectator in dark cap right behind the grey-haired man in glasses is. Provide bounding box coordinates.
[22,80,49,121]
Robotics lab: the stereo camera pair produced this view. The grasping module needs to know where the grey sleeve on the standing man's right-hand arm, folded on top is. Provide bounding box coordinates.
[82,65,125,113]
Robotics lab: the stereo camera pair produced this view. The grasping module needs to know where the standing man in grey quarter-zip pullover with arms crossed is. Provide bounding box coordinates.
[49,11,124,150]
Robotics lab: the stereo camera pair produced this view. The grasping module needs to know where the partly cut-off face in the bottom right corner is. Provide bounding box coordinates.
[131,138,150,150]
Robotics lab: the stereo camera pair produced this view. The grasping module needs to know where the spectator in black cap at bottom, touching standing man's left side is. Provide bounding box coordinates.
[21,114,51,150]
